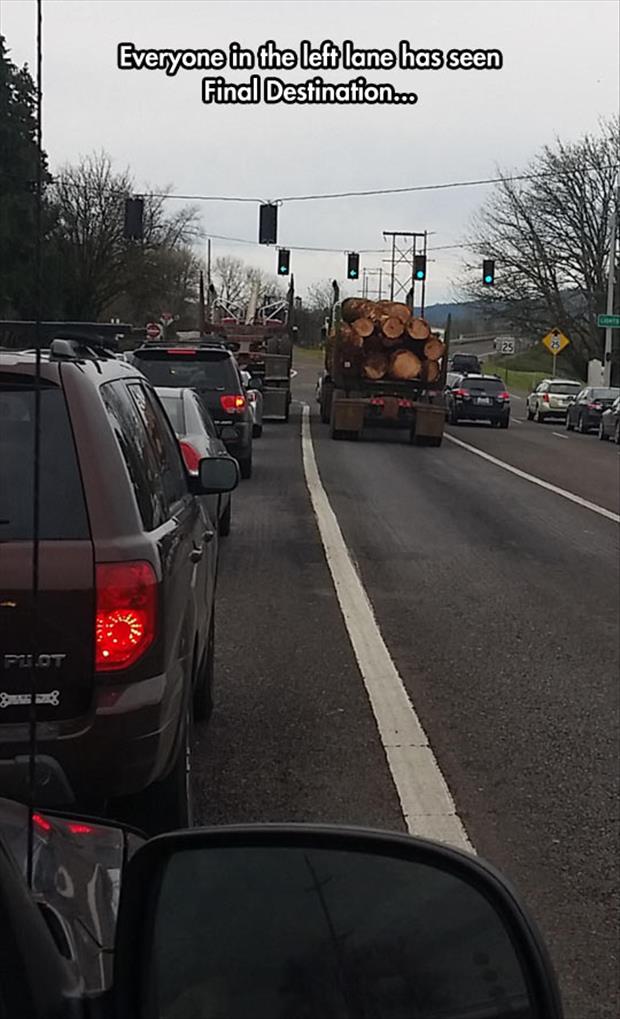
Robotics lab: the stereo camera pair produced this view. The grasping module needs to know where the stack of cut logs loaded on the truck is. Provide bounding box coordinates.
[332,298,446,383]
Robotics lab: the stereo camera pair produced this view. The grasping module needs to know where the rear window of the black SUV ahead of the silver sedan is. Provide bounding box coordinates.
[135,351,241,392]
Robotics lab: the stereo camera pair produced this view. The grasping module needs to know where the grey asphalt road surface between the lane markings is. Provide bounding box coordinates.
[195,356,620,1019]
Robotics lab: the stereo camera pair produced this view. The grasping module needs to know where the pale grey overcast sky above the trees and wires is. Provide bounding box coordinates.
[0,0,619,303]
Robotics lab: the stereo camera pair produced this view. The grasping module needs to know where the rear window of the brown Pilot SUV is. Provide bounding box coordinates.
[0,377,90,541]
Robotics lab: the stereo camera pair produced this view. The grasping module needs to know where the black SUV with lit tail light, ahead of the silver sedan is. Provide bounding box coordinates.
[126,342,254,478]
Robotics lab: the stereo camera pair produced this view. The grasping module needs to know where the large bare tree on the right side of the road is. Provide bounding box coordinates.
[467,119,620,367]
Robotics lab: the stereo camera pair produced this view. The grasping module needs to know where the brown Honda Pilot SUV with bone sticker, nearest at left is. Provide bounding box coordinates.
[0,339,239,832]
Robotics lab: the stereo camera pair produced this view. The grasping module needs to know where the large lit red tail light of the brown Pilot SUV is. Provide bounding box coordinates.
[95,561,157,672]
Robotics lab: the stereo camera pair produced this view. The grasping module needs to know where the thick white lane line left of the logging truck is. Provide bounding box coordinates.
[302,404,474,852]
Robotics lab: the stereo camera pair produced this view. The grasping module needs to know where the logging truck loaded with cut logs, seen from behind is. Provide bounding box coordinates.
[318,298,449,446]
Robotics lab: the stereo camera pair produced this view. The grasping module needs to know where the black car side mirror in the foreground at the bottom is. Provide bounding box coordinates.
[113,824,562,1019]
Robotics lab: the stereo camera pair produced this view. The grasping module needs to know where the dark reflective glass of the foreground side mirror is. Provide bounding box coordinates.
[142,847,543,1019]
